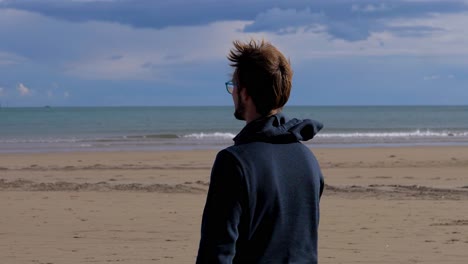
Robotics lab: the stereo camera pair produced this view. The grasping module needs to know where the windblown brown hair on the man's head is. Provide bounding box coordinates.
[228,40,293,116]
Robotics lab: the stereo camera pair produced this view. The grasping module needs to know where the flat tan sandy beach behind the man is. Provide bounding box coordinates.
[0,147,468,264]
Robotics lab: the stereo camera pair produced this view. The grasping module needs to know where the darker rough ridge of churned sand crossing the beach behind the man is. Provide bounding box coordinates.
[0,179,468,200]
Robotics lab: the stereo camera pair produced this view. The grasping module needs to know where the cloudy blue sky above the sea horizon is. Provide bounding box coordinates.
[0,0,468,107]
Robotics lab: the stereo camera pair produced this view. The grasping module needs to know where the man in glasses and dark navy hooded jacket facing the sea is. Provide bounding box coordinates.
[197,40,323,263]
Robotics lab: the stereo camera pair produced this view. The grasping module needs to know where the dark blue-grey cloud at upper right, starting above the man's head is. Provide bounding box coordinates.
[244,1,468,41]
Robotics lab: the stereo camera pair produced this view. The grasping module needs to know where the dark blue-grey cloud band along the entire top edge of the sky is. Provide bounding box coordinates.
[0,0,468,41]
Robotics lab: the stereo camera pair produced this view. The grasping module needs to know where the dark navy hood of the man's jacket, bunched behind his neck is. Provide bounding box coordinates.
[233,113,323,145]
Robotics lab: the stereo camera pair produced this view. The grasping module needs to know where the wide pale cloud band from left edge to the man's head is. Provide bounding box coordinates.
[0,9,252,80]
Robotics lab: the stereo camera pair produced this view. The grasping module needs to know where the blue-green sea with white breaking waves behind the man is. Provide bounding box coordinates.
[0,106,468,153]
